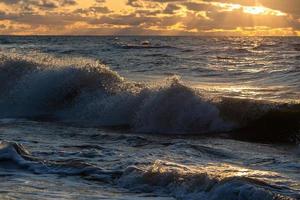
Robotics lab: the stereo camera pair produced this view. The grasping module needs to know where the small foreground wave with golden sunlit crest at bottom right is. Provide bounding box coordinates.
[118,160,292,200]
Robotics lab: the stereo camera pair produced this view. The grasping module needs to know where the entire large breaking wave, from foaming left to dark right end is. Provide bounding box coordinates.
[0,53,300,141]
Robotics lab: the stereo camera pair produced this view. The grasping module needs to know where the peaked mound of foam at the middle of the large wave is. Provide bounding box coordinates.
[135,78,231,134]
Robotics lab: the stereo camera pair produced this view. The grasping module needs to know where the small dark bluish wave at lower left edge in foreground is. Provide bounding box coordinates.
[0,141,120,182]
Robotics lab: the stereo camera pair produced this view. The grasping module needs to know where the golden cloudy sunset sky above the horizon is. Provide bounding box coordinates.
[0,0,300,36]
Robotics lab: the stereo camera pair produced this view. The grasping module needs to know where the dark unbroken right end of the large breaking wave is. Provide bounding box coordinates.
[218,98,300,143]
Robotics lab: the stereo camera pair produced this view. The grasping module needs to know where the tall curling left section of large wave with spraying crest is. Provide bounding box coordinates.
[0,54,124,117]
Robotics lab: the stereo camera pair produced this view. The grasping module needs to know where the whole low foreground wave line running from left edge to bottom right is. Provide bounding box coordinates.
[0,141,293,200]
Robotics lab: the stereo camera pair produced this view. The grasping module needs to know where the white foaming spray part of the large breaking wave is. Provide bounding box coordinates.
[0,54,230,133]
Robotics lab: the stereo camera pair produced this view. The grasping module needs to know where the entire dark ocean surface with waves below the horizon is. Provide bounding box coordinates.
[0,36,300,200]
